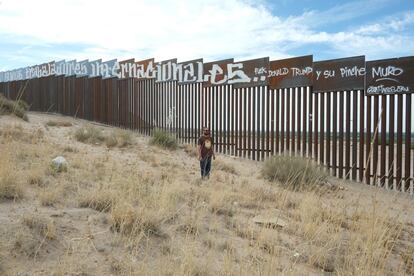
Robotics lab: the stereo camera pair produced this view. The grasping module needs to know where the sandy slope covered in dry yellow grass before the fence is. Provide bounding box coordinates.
[0,113,414,275]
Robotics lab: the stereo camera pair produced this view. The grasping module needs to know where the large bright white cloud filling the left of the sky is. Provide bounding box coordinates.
[0,0,292,63]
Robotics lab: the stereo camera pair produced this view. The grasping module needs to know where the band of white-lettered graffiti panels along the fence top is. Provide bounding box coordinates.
[0,55,414,95]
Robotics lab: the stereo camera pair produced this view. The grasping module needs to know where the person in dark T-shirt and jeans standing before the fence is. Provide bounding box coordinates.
[198,127,216,179]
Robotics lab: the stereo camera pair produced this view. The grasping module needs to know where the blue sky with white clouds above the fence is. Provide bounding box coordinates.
[0,0,414,70]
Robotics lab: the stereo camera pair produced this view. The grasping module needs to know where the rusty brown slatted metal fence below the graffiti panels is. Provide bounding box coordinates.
[0,57,414,194]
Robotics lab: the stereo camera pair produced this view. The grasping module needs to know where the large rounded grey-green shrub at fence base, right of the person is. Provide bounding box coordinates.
[262,156,327,189]
